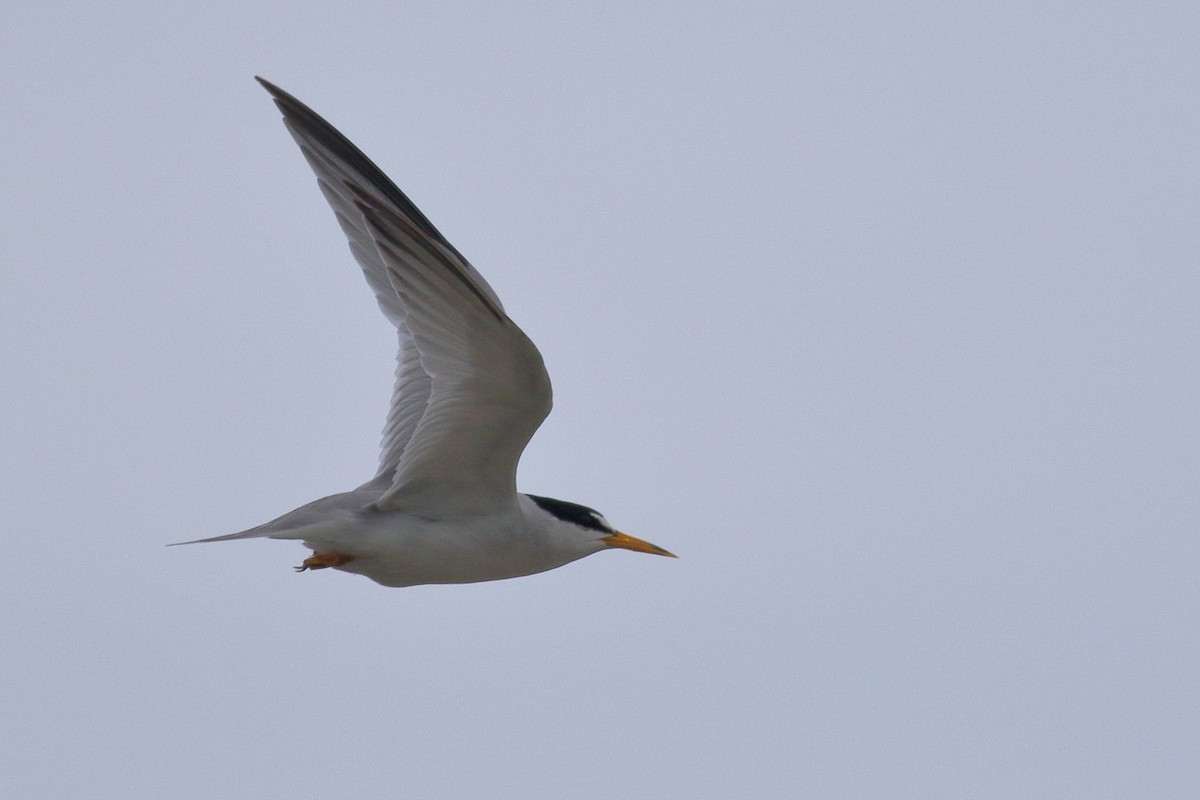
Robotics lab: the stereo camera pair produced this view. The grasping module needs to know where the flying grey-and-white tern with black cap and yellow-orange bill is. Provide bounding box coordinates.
[180,78,674,587]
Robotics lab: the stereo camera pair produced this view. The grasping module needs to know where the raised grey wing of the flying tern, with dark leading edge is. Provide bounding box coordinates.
[259,78,551,516]
